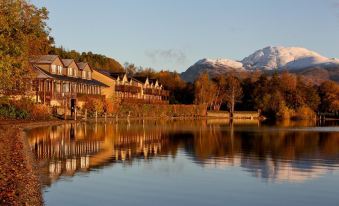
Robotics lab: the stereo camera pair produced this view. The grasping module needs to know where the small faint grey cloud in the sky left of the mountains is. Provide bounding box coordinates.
[145,49,187,65]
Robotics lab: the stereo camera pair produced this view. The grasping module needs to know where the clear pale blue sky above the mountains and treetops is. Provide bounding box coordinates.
[31,0,339,72]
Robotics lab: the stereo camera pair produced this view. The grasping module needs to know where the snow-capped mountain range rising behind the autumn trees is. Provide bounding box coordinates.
[181,46,339,82]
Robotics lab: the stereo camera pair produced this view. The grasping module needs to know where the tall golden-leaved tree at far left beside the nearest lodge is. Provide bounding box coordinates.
[0,0,52,94]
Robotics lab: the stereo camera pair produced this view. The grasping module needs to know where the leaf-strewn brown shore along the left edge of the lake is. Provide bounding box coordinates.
[0,121,75,206]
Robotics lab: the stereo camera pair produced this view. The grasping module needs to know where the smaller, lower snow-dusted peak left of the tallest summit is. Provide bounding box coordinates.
[181,59,246,82]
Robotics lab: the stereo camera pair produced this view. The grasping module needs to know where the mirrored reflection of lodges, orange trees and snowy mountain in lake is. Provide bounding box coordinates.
[27,120,339,186]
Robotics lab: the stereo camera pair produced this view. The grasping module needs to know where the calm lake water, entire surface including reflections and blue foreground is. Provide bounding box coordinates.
[27,121,339,206]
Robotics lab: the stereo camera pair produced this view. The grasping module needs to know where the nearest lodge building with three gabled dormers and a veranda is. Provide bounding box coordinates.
[30,55,108,107]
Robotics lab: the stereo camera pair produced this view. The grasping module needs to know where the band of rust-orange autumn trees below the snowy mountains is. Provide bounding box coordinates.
[194,72,339,119]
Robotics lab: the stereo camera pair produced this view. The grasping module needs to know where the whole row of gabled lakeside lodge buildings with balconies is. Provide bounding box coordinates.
[30,55,169,109]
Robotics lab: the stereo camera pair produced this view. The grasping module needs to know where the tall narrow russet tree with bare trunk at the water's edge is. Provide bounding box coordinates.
[225,75,242,117]
